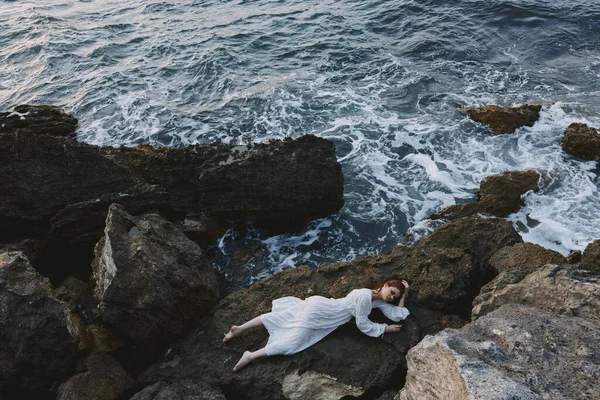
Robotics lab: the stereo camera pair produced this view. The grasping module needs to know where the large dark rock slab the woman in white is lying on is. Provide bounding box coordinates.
[140,219,521,399]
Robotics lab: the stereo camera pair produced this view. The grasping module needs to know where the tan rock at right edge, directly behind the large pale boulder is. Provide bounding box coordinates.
[472,264,600,320]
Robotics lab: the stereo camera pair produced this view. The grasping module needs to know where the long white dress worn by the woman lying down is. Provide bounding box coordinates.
[260,289,409,356]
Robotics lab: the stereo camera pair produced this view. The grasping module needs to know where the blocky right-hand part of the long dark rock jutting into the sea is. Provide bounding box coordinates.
[106,135,344,232]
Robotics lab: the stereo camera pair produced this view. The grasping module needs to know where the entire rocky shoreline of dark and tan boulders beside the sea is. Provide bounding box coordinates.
[0,105,600,400]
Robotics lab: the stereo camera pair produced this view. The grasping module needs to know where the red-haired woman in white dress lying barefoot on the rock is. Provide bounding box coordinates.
[223,280,409,371]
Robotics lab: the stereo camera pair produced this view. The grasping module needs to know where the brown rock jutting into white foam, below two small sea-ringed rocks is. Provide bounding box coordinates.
[429,169,541,219]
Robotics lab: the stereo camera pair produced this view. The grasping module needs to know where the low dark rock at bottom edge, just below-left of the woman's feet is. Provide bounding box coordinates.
[131,380,226,400]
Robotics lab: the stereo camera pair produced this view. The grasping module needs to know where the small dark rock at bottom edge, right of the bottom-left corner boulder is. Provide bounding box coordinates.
[56,353,135,400]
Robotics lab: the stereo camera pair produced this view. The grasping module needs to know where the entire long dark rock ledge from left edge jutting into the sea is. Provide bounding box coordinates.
[0,106,343,282]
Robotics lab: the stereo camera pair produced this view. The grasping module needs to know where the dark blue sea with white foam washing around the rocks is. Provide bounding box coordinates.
[0,0,600,286]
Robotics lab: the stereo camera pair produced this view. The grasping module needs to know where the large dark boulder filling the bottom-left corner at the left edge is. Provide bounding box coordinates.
[0,252,77,398]
